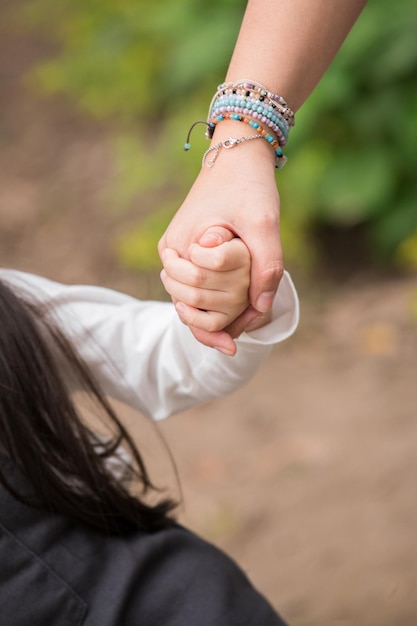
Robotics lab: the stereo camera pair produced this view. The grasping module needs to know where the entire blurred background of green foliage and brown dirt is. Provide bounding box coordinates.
[0,0,417,626]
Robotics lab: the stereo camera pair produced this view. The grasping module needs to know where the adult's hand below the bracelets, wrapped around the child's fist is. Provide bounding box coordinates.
[159,122,283,332]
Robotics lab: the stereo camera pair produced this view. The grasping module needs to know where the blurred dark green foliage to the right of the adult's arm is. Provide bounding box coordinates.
[282,0,417,268]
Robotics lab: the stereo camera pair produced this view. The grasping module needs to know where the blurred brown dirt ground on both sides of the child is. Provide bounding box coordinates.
[0,19,417,626]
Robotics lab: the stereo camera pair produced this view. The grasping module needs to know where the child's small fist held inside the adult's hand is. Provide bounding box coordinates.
[161,226,250,332]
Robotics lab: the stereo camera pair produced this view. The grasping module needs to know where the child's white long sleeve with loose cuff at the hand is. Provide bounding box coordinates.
[0,270,298,419]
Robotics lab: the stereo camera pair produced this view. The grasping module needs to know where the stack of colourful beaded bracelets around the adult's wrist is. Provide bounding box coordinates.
[184,79,295,168]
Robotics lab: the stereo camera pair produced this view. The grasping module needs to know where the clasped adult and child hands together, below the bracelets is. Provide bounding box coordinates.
[159,136,283,354]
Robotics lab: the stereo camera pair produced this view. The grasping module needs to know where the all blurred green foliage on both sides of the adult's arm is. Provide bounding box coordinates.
[25,0,417,268]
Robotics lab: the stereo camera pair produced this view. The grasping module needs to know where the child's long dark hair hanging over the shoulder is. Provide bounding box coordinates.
[0,281,175,533]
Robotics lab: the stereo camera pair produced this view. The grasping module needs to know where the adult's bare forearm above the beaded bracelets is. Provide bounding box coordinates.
[227,0,366,110]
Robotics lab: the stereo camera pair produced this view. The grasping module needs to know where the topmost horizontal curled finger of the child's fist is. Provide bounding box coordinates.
[189,237,250,272]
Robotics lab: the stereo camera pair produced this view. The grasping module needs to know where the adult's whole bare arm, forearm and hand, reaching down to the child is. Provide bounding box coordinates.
[159,0,366,348]
